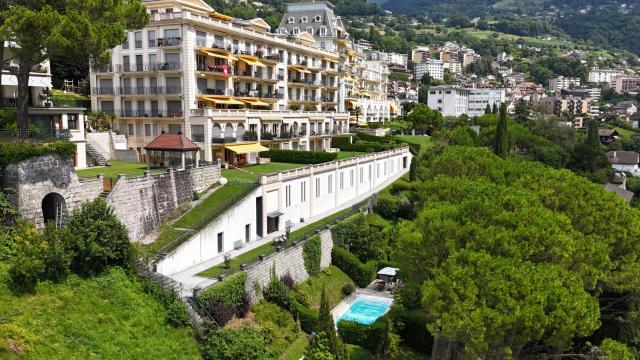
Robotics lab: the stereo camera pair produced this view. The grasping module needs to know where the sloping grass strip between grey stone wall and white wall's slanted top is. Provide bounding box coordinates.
[144,181,258,256]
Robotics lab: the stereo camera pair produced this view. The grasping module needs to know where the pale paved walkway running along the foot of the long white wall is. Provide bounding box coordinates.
[169,170,408,296]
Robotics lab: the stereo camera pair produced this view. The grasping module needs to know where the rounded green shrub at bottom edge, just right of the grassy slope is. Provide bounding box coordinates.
[202,325,274,360]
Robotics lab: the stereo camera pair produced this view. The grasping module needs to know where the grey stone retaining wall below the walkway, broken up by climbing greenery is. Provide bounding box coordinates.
[245,230,333,303]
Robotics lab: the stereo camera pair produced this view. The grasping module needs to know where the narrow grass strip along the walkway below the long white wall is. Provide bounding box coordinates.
[198,208,358,278]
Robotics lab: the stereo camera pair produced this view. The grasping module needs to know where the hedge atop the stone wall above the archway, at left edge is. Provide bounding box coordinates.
[0,140,76,169]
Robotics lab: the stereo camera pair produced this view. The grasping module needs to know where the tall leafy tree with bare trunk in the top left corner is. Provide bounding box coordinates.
[0,0,149,129]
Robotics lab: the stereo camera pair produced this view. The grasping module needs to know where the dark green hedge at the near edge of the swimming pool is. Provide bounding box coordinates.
[338,316,389,354]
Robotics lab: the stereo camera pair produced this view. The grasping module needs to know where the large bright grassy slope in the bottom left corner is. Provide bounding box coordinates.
[0,263,200,360]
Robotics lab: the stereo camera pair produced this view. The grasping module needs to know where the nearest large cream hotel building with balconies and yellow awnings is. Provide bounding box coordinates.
[90,0,393,164]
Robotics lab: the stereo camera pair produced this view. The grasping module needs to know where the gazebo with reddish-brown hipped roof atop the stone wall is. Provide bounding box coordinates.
[144,131,200,169]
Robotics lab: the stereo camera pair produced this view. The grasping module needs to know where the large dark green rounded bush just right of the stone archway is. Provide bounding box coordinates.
[67,198,134,275]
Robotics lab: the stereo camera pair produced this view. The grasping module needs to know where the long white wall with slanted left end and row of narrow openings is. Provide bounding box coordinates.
[156,148,412,276]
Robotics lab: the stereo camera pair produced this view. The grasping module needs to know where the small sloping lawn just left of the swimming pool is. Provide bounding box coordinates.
[298,265,355,308]
